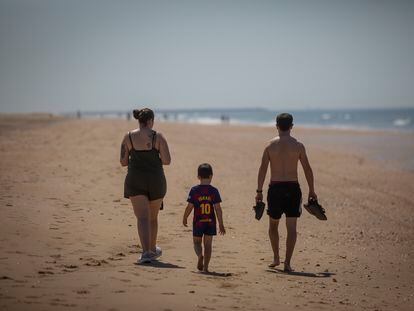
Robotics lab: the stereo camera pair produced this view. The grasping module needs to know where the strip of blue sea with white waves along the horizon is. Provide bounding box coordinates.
[74,108,414,132]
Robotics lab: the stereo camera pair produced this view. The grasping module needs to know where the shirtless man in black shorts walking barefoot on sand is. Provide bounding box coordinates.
[256,113,317,272]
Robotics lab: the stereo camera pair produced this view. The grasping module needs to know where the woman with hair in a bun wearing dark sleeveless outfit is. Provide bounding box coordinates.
[120,108,171,263]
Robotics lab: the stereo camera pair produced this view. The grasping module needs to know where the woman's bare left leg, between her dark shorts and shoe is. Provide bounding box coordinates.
[129,195,151,253]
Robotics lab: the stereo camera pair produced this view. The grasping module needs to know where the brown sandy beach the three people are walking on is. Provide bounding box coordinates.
[0,115,414,311]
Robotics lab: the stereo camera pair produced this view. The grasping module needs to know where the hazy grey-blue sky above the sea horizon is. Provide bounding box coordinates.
[0,0,414,112]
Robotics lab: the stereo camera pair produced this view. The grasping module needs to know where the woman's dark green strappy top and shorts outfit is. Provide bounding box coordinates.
[124,131,167,201]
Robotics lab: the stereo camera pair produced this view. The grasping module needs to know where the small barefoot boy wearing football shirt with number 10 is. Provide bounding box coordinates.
[183,163,226,273]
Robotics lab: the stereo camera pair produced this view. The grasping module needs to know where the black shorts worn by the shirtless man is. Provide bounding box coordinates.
[267,181,302,219]
